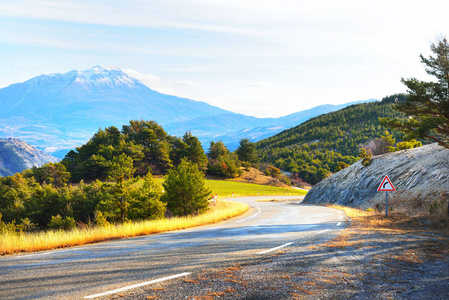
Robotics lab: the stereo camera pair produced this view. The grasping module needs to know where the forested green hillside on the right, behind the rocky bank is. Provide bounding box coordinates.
[256,94,405,184]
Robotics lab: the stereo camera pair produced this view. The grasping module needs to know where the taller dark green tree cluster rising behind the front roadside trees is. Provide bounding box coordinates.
[62,120,207,182]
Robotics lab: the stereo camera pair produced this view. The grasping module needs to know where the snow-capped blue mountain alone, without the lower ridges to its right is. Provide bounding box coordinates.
[0,66,231,157]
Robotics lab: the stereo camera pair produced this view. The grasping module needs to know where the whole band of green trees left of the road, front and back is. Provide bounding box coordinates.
[0,120,256,232]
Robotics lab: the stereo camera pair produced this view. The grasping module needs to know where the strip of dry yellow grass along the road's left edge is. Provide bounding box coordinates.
[0,201,248,254]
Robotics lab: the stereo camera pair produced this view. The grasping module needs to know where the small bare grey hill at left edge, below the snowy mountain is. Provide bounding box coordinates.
[0,138,58,176]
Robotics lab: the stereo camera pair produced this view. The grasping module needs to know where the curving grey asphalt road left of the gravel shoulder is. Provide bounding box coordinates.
[0,197,346,299]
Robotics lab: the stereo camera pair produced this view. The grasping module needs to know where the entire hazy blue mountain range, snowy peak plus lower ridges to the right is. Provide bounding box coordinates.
[0,66,374,158]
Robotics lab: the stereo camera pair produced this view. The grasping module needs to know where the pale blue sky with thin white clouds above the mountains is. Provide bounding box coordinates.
[0,0,449,117]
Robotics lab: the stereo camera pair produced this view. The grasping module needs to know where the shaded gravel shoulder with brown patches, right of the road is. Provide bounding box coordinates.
[109,209,449,299]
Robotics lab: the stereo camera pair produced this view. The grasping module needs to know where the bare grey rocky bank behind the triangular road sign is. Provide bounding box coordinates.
[303,144,449,212]
